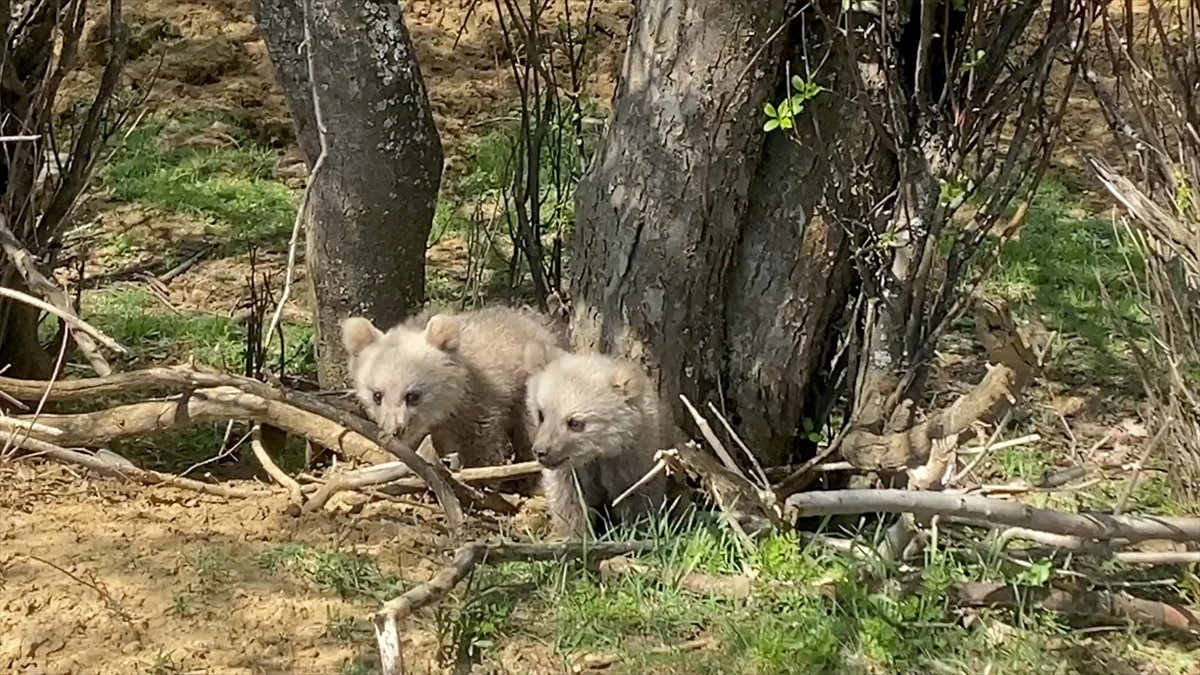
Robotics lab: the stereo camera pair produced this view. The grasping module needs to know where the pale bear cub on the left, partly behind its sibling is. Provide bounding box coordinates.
[342,307,558,466]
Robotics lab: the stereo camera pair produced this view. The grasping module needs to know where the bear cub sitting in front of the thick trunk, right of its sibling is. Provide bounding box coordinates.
[526,345,666,538]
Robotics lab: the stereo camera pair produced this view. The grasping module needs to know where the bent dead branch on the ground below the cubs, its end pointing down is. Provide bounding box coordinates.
[373,542,653,675]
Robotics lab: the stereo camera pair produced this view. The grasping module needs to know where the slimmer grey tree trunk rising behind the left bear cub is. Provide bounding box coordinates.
[256,0,442,388]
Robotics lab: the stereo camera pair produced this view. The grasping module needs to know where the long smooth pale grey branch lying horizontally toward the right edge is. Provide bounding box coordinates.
[787,490,1200,542]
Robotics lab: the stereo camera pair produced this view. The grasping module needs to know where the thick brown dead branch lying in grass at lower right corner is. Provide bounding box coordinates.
[950,583,1200,634]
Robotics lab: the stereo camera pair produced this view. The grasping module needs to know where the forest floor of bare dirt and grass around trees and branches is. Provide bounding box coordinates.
[0,0,1200,675]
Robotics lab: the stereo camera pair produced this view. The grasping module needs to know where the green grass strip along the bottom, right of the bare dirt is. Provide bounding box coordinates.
[427,516,1195,675]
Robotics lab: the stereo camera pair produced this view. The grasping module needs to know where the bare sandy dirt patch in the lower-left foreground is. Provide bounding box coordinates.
[0,464,540,675]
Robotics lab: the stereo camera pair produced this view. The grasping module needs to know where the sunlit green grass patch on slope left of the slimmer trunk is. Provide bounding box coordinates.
[98,115,296,253]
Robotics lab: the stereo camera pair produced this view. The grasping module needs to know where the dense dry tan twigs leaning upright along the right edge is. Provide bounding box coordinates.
[1084,0,1200,500]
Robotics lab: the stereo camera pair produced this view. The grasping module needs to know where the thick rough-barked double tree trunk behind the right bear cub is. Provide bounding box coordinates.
[570,0,884,465]
